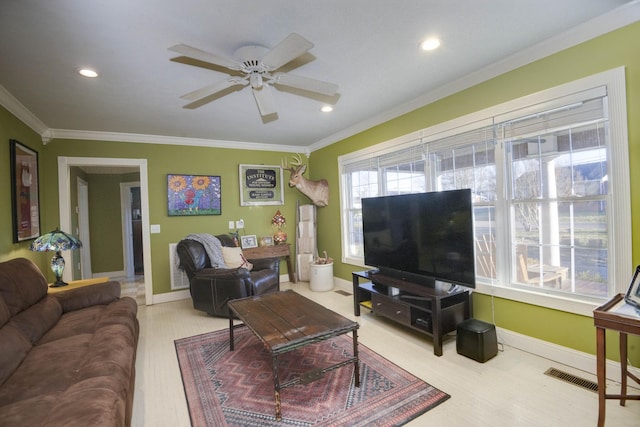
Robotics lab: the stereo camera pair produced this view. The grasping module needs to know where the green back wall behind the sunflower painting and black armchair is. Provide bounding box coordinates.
[41,140,309,294]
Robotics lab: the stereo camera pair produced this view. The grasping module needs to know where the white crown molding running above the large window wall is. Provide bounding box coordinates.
[309,0,640,152]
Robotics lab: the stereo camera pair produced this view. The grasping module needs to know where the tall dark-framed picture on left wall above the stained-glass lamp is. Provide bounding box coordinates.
[9,139,40,243]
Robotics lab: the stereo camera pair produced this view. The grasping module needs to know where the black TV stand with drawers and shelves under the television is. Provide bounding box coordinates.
[352,270,473,356]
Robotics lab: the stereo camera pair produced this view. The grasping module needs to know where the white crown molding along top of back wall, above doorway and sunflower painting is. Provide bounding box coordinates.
[47,129,308,153]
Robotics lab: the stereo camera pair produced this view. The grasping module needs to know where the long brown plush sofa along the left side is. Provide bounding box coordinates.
[0,258,139,427]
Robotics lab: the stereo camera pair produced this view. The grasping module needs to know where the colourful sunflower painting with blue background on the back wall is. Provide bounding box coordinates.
[167,174,222,216]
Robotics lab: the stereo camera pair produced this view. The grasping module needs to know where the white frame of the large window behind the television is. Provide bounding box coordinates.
[338,67,634,316]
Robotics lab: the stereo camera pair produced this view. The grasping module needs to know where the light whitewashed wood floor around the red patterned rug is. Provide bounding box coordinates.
[132,282,640,427]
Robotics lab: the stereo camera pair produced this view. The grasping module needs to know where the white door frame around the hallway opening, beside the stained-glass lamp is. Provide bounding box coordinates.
[58,156,153,305]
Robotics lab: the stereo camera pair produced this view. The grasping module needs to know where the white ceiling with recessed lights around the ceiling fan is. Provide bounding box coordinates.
[0,0,640,151]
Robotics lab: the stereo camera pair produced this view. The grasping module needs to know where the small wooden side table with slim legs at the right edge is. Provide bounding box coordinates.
[593,294,640,427]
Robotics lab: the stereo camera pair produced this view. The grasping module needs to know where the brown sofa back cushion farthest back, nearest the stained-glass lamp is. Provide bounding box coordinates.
[0,258,47,316]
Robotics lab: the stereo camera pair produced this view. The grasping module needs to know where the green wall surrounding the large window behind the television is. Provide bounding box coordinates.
[310,23,640,366]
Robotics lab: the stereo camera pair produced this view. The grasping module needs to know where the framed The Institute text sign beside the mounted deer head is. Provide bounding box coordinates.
[240,165,284,206]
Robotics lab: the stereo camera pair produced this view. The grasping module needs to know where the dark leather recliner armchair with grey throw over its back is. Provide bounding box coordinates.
[176,234,280,317]
